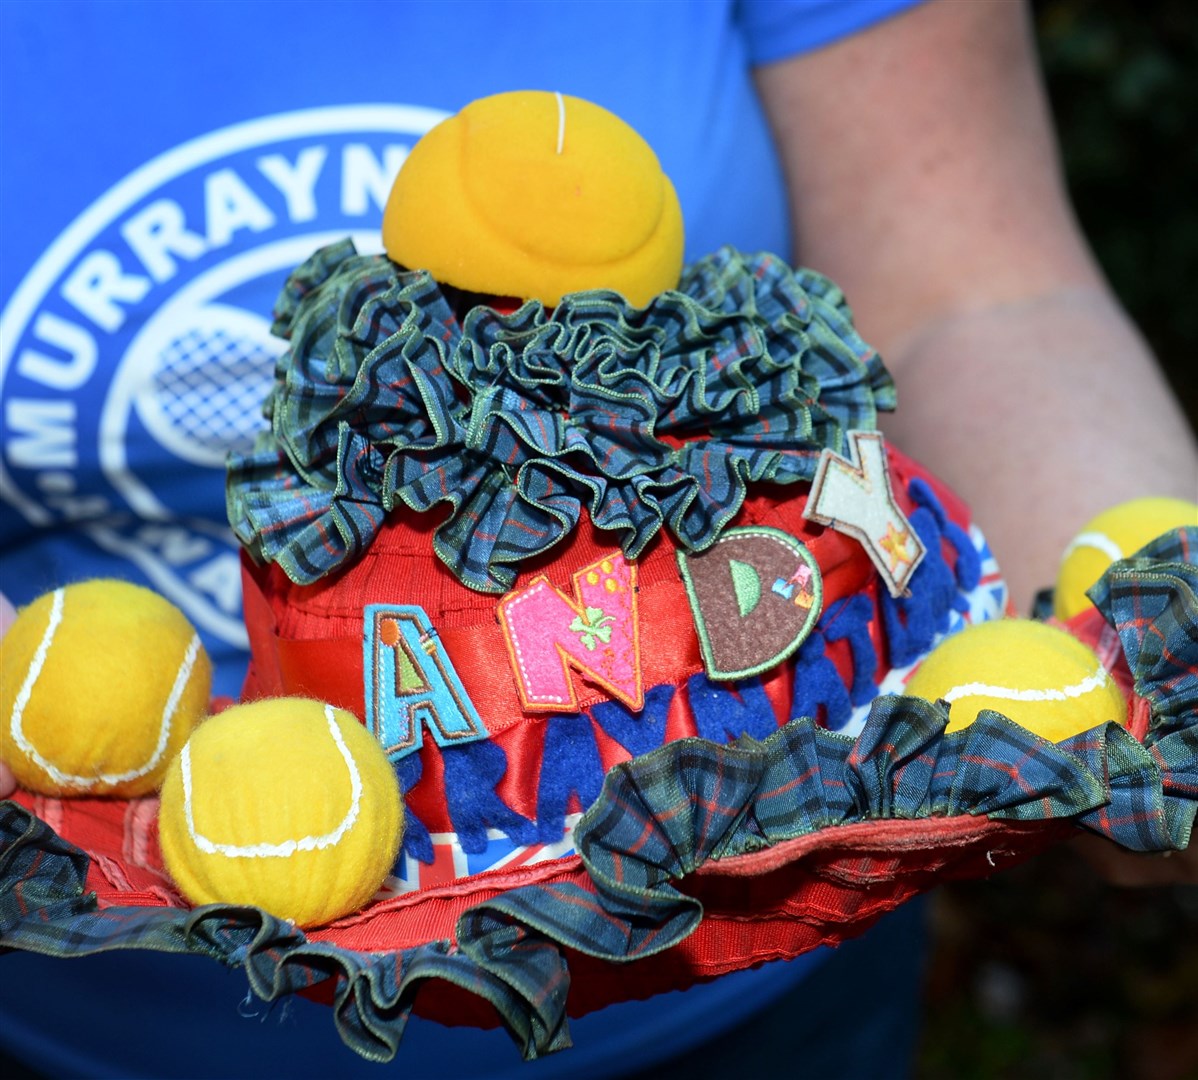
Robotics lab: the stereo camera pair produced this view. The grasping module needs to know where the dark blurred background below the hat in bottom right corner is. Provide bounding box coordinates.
[915,845,1198,1080]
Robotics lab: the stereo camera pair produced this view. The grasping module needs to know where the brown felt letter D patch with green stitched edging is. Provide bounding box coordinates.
[677,526,823,681]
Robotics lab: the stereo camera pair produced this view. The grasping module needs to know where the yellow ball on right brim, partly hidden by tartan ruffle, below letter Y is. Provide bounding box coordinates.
[907,619,1127,742]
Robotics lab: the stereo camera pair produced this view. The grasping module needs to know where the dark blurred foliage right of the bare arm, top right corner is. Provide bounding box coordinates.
[1033,0,1198,427]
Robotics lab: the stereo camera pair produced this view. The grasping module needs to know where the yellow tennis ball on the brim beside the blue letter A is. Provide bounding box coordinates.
[158,698,404,927]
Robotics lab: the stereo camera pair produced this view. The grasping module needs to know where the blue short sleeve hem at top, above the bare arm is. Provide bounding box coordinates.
[737,0,924,66]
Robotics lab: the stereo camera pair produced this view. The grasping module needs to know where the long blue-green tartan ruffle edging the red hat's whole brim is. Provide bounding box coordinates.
[0,529,1198,1060]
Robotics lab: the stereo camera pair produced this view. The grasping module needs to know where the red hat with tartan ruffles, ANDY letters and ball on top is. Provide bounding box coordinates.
[0,95,1198,1057]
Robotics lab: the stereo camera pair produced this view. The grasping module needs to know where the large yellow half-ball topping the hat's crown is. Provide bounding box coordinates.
[382,91,683,307]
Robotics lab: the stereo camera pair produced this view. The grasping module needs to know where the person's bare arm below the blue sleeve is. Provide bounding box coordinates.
[758,0,1198,612]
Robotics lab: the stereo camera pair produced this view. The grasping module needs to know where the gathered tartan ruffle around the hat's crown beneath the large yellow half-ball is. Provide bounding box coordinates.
[228,241,895,593]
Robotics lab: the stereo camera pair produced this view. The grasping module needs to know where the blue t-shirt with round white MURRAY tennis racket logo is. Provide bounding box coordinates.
[0,0,913,1075]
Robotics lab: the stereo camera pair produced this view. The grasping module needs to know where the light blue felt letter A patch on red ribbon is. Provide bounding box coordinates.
[362,603,488,763]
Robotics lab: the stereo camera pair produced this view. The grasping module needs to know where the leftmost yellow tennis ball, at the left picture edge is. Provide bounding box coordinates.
[0,580,212,797]
